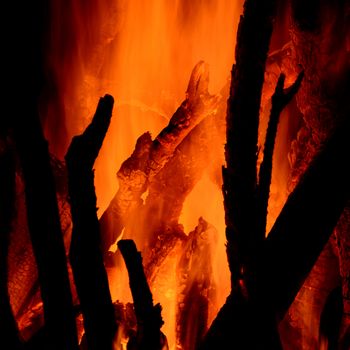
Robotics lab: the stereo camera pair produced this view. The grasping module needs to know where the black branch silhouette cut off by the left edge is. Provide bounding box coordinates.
[0,138,22,350]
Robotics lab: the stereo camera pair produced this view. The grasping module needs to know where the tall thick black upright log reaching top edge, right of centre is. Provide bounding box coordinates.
[223,0,276,288]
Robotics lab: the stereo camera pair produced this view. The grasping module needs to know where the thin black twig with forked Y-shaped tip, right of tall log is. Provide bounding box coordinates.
[256,72,304,239]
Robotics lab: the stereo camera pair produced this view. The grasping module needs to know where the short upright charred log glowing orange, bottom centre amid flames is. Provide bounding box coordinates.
[176,218,218,350]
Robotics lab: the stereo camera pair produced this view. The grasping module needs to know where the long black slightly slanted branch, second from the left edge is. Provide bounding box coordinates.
[8,0,78,350]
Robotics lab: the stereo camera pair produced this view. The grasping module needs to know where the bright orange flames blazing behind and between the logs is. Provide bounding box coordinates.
[39,0,294,347]
